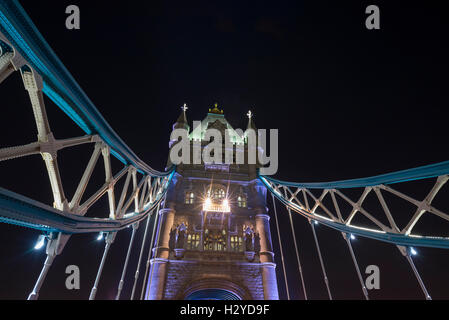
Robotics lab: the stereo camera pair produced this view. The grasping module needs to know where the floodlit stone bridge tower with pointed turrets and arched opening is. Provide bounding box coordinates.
[145,105,279,300]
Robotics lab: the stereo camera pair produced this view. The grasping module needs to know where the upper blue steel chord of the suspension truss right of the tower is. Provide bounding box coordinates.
[264,161,449,189]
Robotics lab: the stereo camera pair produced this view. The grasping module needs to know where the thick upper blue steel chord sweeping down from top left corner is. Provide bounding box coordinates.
[0,0,173,176]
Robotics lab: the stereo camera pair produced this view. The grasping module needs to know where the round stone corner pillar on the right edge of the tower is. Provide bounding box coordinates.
[256,213,279,300]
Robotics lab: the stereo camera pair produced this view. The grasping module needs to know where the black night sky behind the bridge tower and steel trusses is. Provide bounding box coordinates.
[0,0,449,299]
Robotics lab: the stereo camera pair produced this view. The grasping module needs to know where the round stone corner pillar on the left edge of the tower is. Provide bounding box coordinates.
[147,208,175,300]
